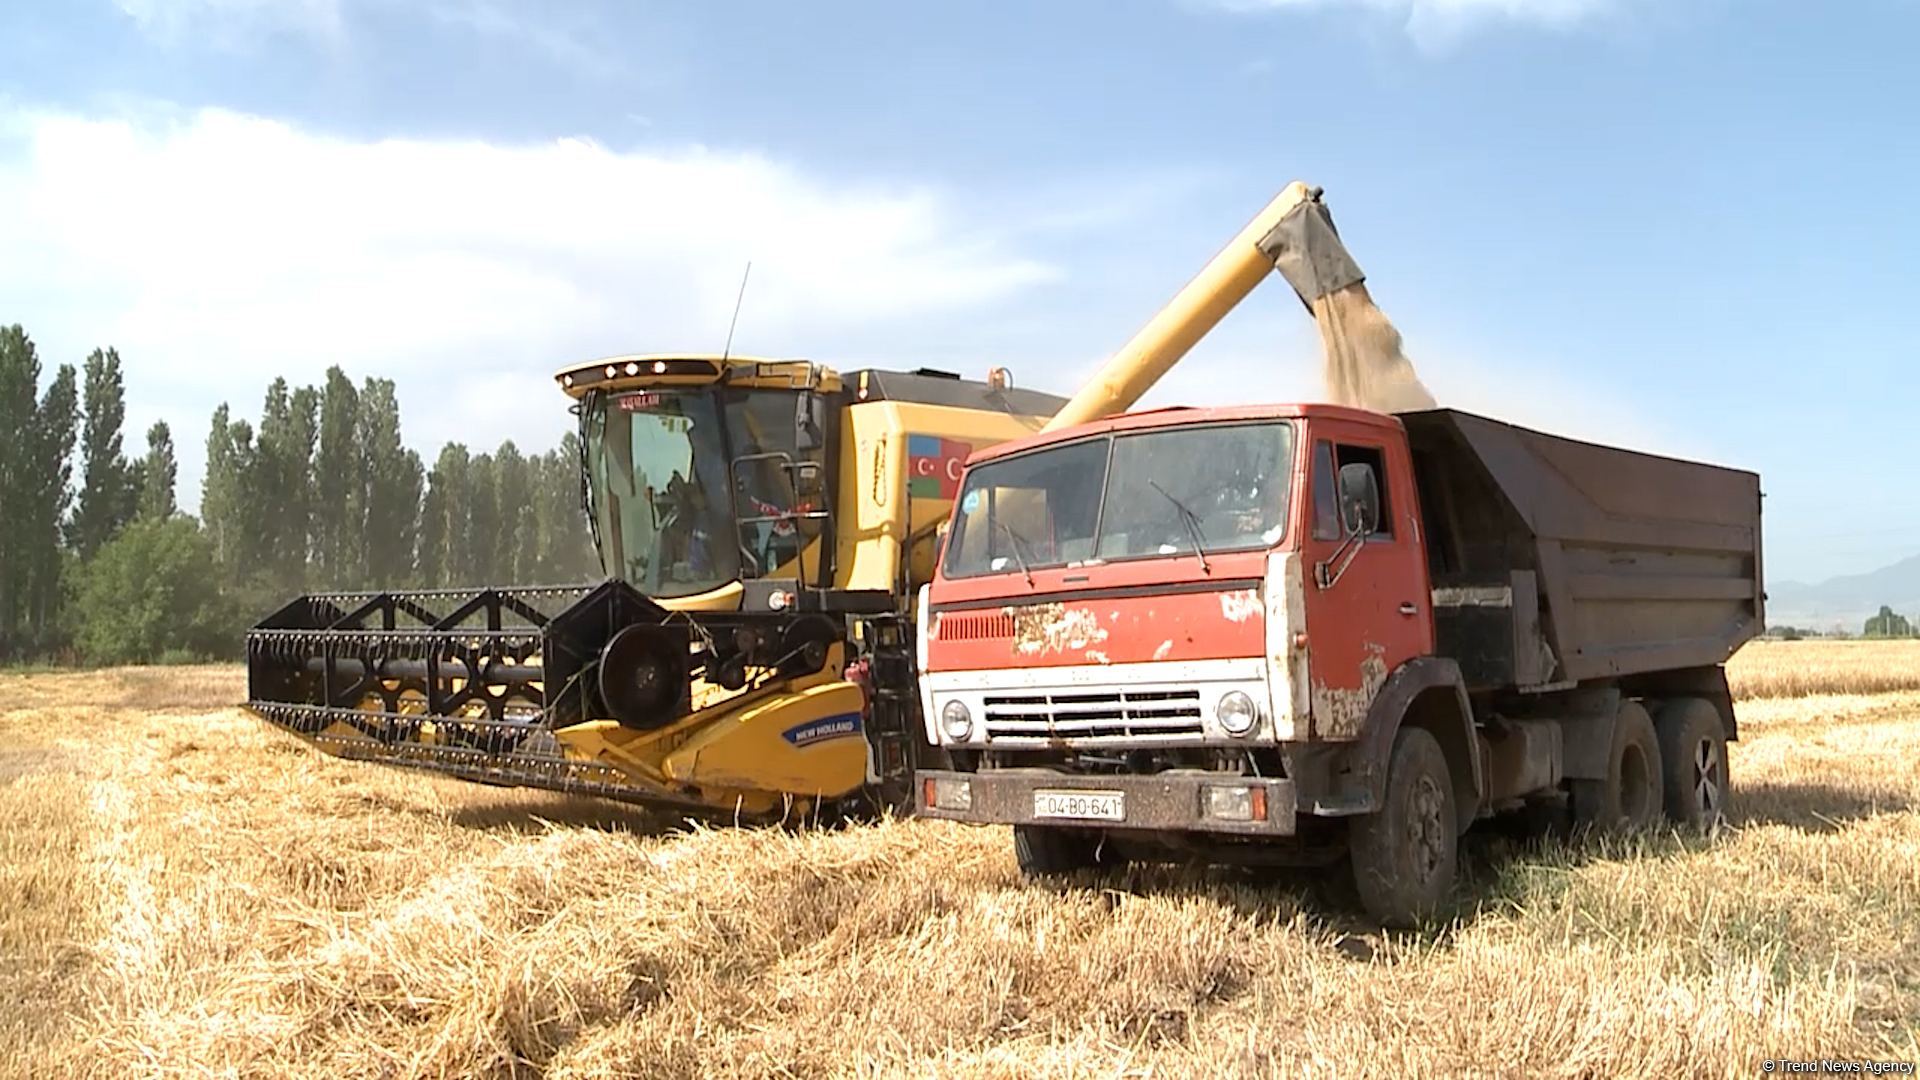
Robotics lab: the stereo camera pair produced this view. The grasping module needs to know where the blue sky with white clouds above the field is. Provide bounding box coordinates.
[0,0,1920,578]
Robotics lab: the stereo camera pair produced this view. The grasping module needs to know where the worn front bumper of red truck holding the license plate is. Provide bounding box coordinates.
[916,769,1298,836]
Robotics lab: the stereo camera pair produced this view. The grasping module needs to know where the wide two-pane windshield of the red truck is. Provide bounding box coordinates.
[941,421,1294,577]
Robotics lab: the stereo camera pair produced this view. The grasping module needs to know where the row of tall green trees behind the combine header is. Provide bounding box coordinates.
[0,325,599,663]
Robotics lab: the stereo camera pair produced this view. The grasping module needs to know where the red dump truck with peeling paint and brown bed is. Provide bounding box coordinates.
[916,405,1764,926]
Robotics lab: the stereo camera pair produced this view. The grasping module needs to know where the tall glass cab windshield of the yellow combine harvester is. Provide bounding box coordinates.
[586,386,822,598]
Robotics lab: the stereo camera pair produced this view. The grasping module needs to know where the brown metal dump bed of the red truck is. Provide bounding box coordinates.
[1400,409,1764,690]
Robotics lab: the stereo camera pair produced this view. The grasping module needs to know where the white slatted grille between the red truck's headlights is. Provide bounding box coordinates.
[983,690,1204,744]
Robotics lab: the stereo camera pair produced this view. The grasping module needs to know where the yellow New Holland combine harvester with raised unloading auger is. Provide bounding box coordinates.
[248,183,1361,819]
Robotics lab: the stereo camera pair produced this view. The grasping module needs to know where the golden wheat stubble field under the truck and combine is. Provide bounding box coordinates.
[0,642,1920,1076]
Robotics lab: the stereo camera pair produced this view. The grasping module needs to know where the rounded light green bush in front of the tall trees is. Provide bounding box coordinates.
[73,517,240,663]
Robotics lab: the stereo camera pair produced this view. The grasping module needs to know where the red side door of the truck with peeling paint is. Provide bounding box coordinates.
[1302,425,1432,738]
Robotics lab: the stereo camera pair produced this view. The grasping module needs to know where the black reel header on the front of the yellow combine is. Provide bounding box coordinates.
[248,580,699,807]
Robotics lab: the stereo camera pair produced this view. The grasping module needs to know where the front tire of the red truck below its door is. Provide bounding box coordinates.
[1348,728,1459,928]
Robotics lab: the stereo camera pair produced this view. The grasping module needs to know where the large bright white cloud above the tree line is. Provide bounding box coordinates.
[0,110,1054,505]
